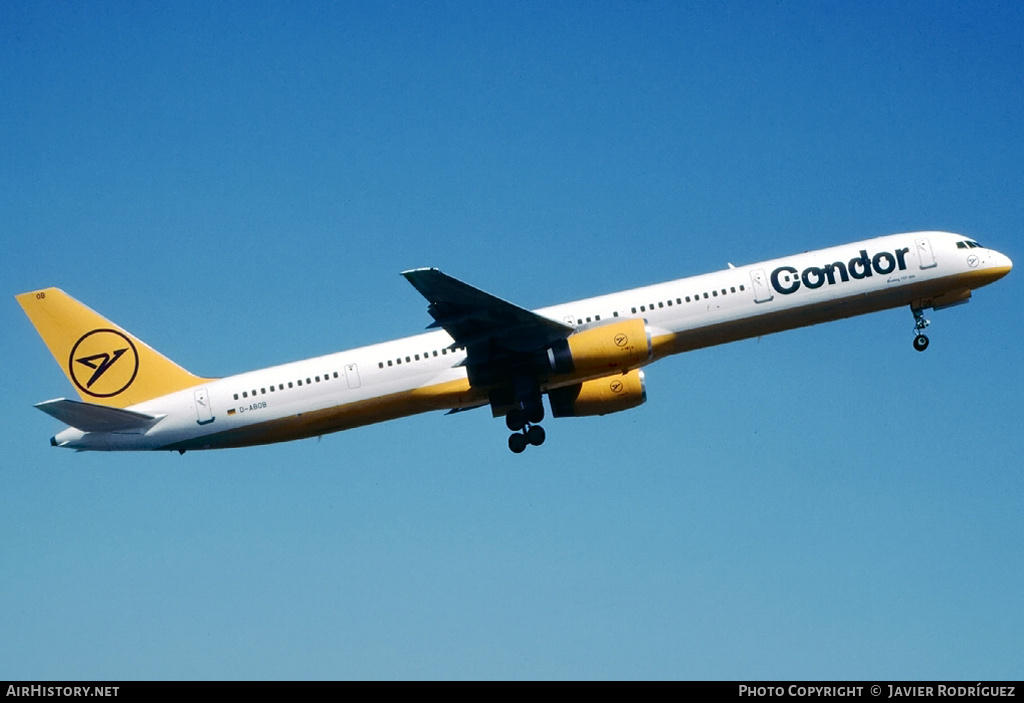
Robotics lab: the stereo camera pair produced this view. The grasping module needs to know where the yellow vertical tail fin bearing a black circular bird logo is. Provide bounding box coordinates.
[17,288,210,407]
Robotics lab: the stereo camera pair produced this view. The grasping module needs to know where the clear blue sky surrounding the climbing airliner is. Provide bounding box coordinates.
[0,2,1024,679]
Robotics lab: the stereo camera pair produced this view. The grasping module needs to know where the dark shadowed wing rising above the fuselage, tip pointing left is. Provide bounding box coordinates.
[401,268,574,362]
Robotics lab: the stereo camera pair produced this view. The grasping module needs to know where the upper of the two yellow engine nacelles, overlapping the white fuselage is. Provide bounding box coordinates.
[548,319,653,376]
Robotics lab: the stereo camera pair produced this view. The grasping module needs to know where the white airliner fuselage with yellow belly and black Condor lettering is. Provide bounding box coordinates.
[52,232,1012,450]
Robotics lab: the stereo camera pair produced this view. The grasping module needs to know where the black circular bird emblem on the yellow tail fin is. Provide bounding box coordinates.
[68,329,138,398]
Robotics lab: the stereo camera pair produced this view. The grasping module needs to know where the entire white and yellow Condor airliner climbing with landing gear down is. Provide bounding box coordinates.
[16,231,1013,454]
